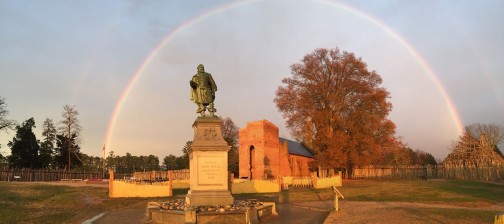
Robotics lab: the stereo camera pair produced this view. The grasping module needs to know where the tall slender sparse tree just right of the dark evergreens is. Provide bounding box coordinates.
[58,104,81,170]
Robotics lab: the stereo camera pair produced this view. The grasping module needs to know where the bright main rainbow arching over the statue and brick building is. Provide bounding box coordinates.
[105,0,463,152]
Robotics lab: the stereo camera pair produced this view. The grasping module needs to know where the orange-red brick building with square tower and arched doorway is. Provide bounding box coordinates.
[239,120,313,179]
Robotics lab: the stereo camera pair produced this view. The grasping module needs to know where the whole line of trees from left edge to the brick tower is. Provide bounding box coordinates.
[0,97,238,174]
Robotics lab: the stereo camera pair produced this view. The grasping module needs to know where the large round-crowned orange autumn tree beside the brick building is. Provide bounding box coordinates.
[274,48,395,168]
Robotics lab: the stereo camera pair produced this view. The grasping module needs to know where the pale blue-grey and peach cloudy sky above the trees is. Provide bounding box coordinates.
[0,0,504,160]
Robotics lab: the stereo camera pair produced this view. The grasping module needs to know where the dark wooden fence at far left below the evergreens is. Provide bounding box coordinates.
[0,169,103,182]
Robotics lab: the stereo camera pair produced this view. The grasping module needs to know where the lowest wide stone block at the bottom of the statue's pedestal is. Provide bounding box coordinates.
[185,190,234,206]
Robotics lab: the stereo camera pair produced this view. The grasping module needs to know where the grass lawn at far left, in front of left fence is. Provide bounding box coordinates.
[0,182,158,223]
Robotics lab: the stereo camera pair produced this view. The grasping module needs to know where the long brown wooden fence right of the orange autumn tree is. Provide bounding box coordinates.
[351,165,504,182]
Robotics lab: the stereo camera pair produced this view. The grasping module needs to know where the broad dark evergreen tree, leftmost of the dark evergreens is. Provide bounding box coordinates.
[8,118,40,169]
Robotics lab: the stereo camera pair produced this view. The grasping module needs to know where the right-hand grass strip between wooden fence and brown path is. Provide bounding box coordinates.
[341,179,504,207]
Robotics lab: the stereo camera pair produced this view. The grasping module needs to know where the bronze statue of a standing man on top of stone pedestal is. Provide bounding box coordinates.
[189,64,217,117]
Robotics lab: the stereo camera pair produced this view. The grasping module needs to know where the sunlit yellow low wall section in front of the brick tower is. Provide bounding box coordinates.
[231,179,280,194]
